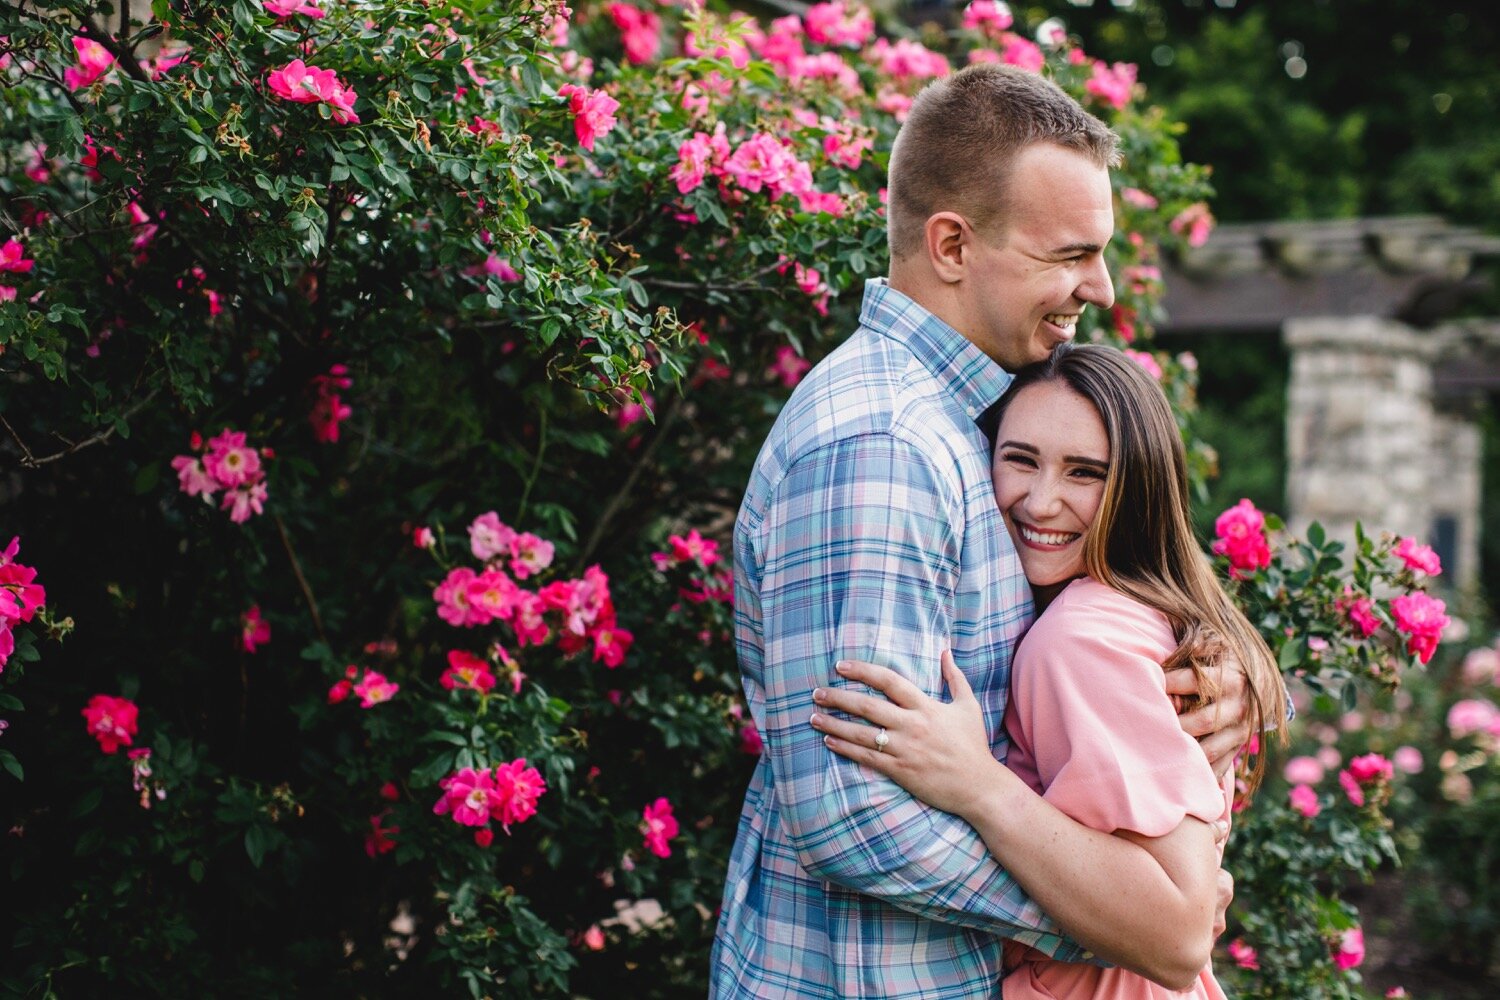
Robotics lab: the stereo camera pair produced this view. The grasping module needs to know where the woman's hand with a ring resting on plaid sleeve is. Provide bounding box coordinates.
[812,651,1010,816]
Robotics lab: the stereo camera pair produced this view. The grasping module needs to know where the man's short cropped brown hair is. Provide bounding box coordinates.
[887,63,1119,261]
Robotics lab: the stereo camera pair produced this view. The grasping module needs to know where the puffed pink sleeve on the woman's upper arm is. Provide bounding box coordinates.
[1011,585,1224,837]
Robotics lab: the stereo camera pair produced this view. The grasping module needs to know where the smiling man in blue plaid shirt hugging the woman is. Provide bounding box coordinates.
[711,66,1248,1000]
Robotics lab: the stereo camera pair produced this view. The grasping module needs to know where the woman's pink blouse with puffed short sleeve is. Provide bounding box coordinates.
[1004,577,1235,1000]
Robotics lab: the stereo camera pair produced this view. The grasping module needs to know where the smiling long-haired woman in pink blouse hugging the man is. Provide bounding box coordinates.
[813,345,1286,1000]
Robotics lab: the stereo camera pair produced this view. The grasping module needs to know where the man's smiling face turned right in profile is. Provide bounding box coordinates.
[960,142,1115,372]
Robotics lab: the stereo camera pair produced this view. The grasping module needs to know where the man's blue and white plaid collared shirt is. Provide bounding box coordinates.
[710,280,1083,1000]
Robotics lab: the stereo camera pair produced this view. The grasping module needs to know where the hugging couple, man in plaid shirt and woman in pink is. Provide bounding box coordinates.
[710,66,1286,1000]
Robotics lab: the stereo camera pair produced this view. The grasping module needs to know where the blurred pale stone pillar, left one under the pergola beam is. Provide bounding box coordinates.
[1283,316,1437,554]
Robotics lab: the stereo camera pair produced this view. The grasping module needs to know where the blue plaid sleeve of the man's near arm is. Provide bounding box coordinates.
[756,435,1083,961]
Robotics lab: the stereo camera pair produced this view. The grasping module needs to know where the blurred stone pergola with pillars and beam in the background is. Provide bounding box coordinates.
[1163,216,1500,586]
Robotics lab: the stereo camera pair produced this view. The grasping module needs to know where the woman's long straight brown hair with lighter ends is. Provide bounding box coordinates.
[1002,343,1287,790]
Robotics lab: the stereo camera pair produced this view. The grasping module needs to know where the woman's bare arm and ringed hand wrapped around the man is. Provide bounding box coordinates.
[813,654,1218,990]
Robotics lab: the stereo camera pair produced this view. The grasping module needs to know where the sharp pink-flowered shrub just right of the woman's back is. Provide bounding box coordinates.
[1212,501,1449,1000]
